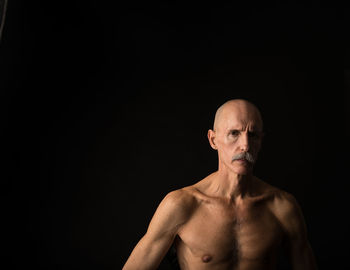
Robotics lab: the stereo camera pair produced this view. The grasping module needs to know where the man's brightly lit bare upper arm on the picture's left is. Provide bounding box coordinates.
[123,190,194,270]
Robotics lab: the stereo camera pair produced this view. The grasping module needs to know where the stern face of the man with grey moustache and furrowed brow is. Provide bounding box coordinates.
[209,105,262,175]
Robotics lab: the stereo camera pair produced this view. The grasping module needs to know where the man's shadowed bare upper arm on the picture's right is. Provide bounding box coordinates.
[276,193,316,270]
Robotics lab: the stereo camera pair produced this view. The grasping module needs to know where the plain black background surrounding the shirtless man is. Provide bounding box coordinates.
[0,0,350,269]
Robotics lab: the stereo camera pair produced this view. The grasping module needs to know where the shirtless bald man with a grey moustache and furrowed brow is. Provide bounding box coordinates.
[123,99,316,270]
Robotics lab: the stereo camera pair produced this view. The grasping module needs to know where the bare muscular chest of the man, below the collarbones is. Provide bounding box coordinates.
[178,200,282,263]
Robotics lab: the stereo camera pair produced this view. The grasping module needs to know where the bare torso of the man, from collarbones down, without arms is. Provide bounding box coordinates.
[175,178,283,270]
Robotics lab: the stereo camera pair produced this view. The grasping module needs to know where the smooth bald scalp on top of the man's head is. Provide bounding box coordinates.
[213,99,263,131]
